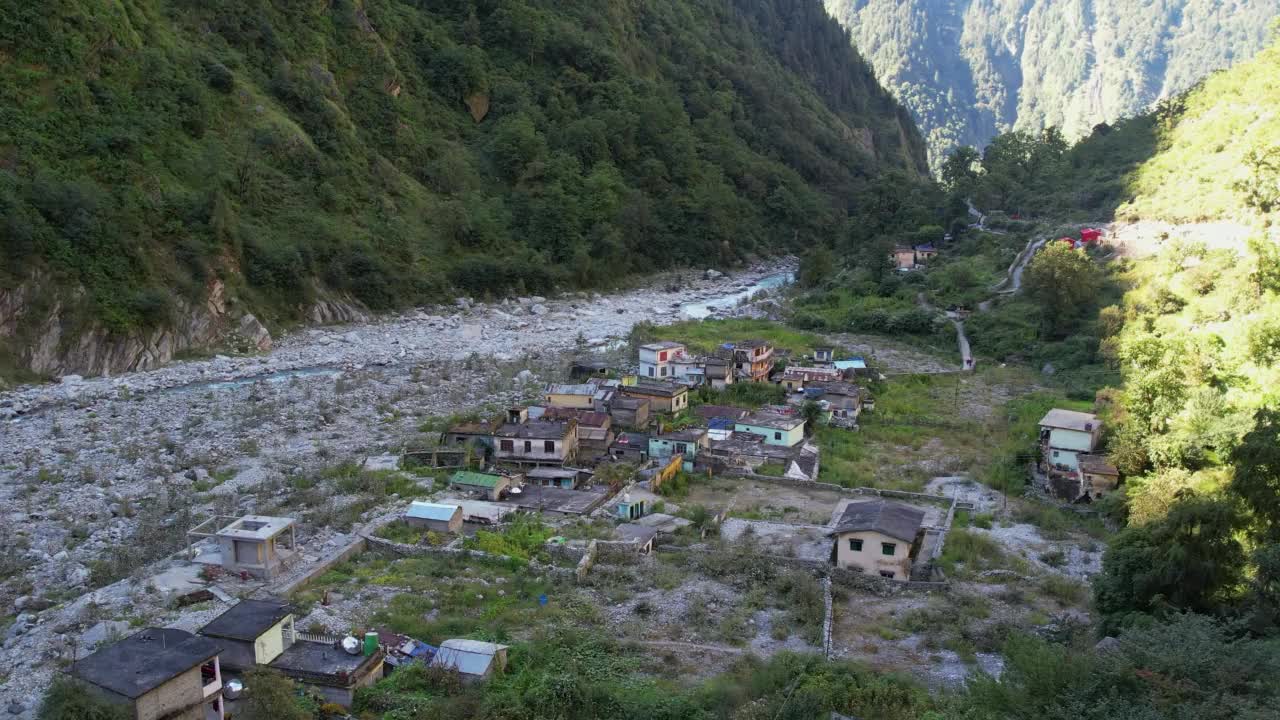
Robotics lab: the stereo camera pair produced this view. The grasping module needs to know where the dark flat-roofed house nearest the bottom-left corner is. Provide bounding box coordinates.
[67,628,223,720]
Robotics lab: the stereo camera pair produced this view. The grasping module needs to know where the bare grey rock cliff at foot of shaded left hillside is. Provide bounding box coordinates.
[0,277,271,375]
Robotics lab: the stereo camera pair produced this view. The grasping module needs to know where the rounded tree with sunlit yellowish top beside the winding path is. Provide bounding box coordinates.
[1024,242,1102,338]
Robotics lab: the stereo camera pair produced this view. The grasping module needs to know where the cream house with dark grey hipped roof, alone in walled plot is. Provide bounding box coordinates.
[828,500,924,580]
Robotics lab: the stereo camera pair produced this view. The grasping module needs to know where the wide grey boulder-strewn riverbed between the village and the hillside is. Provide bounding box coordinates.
[0,259,795,716]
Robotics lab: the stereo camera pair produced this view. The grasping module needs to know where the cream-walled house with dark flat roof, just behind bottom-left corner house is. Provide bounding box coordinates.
[200,600,294,671]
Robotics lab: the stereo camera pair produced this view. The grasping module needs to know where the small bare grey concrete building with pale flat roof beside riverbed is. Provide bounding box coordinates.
[187,515,298,580]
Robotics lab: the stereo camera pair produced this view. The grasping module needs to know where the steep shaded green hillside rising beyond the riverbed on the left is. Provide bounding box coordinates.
[0,0,925,373]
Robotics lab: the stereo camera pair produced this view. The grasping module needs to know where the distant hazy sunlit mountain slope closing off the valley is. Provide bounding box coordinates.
[824,0,1280,163]
